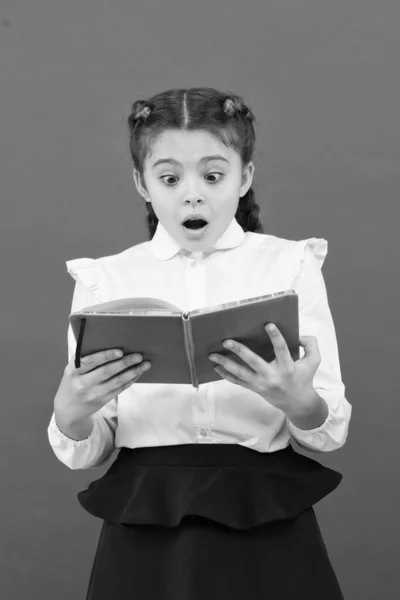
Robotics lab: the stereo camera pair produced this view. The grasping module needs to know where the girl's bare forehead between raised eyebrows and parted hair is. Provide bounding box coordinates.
[148,129,236,164]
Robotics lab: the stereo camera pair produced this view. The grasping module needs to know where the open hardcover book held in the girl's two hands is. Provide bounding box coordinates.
[69,290,299,389]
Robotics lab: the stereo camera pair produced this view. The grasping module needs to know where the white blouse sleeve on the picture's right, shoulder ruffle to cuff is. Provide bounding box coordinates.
[287,238,352,452]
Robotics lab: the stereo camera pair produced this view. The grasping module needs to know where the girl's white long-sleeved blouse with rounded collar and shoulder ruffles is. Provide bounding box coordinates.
[48,219,352,469]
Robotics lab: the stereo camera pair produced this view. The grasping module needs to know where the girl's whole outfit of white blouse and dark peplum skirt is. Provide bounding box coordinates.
[48,219,352,600]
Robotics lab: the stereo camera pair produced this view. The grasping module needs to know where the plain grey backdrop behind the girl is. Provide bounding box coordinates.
[0,0,400,600]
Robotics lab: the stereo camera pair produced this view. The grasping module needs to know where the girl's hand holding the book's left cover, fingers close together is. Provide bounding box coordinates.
[54,349,151,423]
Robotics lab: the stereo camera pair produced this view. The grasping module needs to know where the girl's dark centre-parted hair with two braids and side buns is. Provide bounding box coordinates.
[128,88,264,239]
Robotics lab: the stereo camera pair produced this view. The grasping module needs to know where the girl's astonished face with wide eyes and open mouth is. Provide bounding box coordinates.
[133,129,254,252]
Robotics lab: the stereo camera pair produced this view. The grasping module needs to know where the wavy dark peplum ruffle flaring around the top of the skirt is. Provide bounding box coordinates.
[78,446,342,529]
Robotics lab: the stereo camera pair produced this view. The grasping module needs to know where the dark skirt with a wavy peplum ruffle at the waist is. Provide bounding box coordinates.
[78,444,343,600]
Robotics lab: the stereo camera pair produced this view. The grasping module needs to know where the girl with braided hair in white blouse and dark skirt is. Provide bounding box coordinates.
[48,88,352,600]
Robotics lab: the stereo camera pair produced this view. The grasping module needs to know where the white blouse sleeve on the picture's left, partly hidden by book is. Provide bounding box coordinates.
[47,258,118,469]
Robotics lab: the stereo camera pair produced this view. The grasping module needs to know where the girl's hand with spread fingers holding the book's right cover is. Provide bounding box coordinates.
[209,323,321,412]
